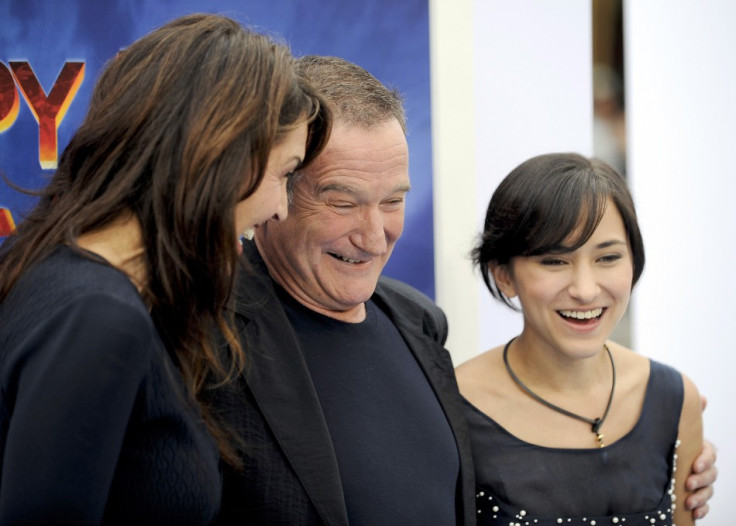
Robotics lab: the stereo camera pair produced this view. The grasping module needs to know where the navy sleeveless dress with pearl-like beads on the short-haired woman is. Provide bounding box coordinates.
[464,361,683,526]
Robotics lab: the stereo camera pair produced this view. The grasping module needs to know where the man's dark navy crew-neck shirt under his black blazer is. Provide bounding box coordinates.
[281,291,459,526]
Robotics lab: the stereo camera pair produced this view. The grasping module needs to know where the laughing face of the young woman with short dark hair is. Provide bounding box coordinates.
[494,199,633,357]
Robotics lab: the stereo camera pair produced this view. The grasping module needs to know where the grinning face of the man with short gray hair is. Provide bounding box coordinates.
[256,120,409,322]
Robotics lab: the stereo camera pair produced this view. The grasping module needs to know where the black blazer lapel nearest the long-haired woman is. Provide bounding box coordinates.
[235,246,348,525]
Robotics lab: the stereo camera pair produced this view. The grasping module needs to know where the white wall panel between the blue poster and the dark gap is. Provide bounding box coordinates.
[430,0,593,364]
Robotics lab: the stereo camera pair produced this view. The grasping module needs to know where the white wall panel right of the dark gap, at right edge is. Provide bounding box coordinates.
[624,0,736,526]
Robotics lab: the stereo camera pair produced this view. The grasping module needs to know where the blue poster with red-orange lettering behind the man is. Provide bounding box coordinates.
[0,0,434,297]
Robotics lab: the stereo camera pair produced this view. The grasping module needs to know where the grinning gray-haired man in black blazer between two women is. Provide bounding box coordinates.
[219,56,716,525]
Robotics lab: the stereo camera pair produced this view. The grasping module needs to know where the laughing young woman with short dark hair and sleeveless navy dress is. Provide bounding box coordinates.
[457,154,702,526]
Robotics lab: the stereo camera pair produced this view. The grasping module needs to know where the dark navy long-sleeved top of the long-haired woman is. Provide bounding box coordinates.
[0,248,221,525]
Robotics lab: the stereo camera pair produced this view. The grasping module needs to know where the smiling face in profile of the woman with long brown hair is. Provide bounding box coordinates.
[235,123,307,251]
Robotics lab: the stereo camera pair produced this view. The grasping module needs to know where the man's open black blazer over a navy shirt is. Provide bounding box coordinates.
[217,243,475,525]
